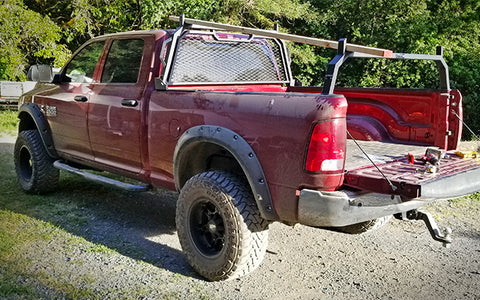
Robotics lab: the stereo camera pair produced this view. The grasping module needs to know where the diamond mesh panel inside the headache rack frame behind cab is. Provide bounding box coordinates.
[170,34,286,84]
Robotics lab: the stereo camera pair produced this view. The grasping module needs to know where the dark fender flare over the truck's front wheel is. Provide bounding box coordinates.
[18,102,58,159]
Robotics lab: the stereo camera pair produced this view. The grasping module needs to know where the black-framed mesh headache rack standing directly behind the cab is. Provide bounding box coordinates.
[155,16,293,90]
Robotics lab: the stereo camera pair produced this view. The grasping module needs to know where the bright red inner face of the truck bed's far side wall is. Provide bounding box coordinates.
[289,87,462,150]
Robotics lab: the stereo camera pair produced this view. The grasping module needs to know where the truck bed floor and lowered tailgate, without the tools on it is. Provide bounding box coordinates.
[344,140,480,199]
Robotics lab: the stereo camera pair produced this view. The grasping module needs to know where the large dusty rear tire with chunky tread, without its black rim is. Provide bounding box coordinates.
[175,171,269,281]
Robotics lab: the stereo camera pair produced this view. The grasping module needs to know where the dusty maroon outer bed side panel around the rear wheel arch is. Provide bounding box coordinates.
[148,91,347,220]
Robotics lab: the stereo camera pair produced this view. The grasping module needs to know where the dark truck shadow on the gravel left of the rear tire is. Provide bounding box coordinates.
[0,154,200,278]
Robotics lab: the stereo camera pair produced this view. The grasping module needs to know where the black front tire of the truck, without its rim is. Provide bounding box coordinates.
[14,130,60,194]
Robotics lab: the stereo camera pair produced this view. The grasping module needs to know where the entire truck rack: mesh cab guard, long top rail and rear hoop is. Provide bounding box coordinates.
[161,15,450,95]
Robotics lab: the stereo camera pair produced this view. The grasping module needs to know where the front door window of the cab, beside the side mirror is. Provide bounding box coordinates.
[65,41,105,83]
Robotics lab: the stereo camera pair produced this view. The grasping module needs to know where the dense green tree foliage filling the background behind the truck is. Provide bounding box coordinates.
[0,0,480,137]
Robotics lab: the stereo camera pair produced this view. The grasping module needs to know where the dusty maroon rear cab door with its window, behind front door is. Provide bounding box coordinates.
[88,36,153,174]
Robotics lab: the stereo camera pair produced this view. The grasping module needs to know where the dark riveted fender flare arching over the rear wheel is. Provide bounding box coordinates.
[173,125,279,220]
